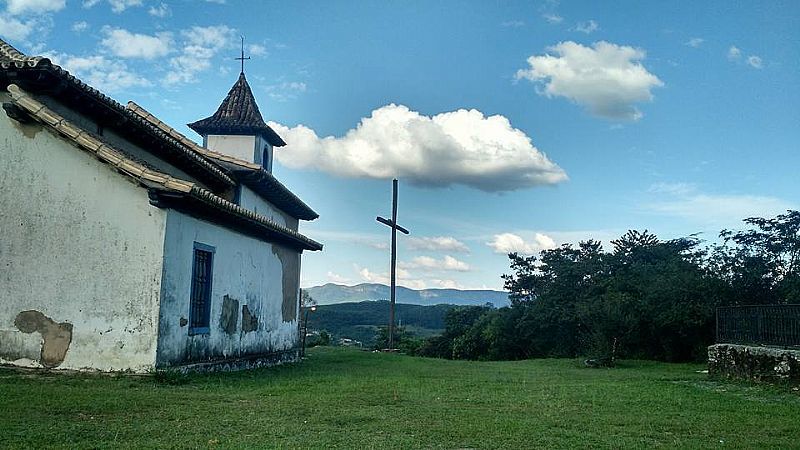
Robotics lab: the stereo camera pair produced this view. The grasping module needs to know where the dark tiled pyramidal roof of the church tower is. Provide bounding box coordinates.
[188,72,286,147]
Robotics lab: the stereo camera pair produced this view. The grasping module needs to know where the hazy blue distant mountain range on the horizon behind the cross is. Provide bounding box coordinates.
[304,283,509,307]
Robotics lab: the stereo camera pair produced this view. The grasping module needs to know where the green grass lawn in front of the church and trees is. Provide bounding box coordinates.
[0,348,800,448]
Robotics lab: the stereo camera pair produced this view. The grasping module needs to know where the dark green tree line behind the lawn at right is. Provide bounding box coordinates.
[410,210,800,361]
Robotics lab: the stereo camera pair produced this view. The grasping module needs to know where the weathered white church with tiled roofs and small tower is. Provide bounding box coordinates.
[0,40,322,372]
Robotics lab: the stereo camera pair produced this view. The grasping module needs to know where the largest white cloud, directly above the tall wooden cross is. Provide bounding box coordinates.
[270,104,567,192]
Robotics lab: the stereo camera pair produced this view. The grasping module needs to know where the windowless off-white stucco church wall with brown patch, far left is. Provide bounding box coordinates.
[0,94,166,371]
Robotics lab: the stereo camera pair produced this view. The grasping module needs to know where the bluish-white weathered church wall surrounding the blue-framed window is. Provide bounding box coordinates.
[158,210,300,367]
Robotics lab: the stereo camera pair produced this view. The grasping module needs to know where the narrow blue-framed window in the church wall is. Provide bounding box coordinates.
[189,242,215,334]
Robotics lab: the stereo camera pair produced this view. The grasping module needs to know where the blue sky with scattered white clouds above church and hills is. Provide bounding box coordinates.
[0,0,800,288]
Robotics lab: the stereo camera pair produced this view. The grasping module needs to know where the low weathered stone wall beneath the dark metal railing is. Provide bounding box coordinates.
[708,344,800,383]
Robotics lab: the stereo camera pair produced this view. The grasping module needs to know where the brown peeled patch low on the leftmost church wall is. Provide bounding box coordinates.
[14,310,72,369]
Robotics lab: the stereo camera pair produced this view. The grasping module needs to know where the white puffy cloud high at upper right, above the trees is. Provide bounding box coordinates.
[516,41,664,120]
